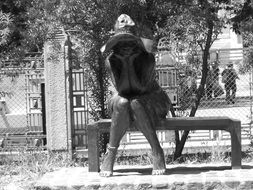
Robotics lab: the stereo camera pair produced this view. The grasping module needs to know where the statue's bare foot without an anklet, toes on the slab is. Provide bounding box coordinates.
[152,153,166,175]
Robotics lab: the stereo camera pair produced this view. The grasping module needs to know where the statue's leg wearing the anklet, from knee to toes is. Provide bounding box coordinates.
[100,96,130,177]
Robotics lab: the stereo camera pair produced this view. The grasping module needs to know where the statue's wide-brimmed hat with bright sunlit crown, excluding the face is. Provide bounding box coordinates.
[101,14,147,53]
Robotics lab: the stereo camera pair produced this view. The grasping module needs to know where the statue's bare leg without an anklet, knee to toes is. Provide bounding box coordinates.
[131,100,166,175]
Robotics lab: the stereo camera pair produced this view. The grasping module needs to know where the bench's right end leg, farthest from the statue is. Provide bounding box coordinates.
[230,121,242,169]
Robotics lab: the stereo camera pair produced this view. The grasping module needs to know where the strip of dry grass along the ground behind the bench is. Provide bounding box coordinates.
[0,146,253,190]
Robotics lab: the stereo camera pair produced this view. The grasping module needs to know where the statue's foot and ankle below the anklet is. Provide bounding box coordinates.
[99,146,117,177]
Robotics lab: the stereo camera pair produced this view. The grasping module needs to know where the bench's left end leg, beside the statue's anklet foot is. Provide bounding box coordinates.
[87,125,100,172]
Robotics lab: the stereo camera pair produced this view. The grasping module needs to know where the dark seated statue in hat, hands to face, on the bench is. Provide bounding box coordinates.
[100,14,171,177]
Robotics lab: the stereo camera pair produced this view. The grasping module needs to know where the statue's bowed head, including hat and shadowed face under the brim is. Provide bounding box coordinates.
[101,14,149,54]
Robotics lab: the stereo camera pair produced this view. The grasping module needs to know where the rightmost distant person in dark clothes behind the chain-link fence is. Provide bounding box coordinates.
[221,63,239,104]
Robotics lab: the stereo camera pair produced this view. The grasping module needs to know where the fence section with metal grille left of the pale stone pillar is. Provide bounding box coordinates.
[0,68,44,133]
